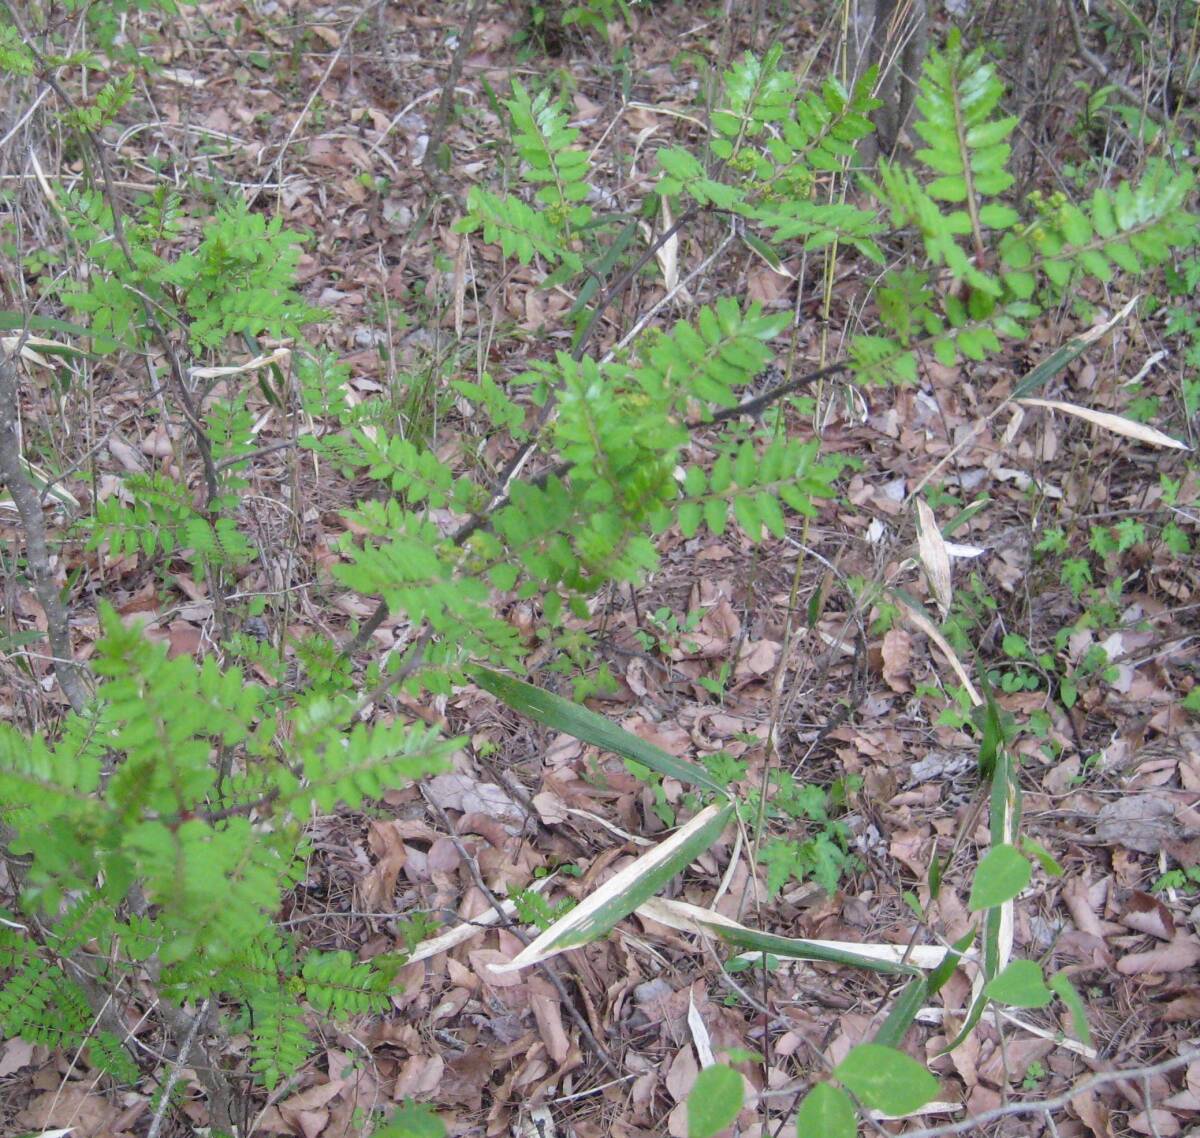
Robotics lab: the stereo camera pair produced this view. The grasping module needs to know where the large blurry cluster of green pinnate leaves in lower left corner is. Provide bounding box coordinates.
[0,613,457,1086]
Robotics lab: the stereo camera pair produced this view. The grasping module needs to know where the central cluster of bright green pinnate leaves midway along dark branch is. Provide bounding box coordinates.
[324,298,838,681]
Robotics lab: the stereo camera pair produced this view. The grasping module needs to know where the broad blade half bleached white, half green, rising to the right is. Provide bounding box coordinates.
[492,802,733,972]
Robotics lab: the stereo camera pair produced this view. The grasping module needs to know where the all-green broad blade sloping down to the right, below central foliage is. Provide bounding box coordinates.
[470,666,726,796]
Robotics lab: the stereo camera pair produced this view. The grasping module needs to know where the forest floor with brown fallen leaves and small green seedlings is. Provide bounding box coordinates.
[0,0,1200,1138]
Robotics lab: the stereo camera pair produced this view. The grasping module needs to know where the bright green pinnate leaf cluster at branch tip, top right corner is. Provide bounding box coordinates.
[850,31,1200,382]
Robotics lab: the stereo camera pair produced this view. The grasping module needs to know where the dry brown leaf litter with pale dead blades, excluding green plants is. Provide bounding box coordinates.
[0,2,1200,1138]
